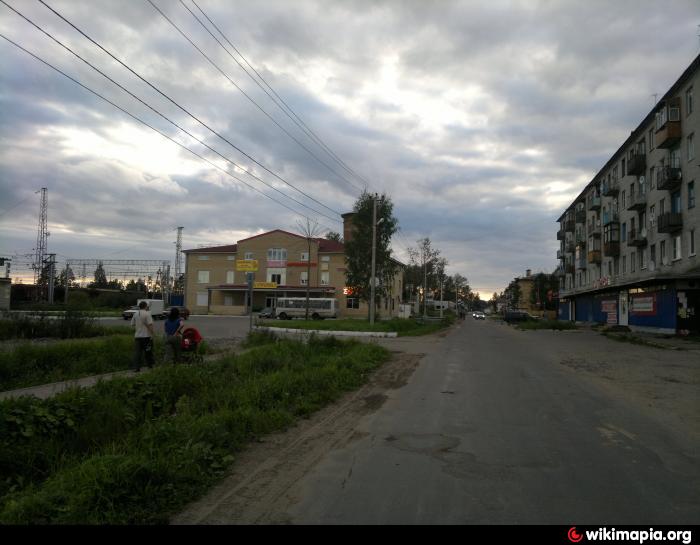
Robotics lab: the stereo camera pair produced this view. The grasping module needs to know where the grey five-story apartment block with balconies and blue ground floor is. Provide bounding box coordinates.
[557,56,700,332]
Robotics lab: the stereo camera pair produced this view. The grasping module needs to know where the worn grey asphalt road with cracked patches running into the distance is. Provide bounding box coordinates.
[278,320,700,525]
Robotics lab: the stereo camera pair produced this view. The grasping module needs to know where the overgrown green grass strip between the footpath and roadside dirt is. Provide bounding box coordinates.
[0,337,389,524]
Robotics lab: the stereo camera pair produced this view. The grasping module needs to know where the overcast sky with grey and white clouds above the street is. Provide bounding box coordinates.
[0,0,700,298]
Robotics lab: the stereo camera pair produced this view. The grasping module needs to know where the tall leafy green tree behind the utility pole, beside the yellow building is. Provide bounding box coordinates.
[345,191,398,314]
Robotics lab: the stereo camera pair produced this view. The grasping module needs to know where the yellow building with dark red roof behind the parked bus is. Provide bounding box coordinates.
[183,219,403,317]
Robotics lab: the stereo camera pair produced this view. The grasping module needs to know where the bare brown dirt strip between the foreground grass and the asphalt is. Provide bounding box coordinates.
[171,352,422,524]
